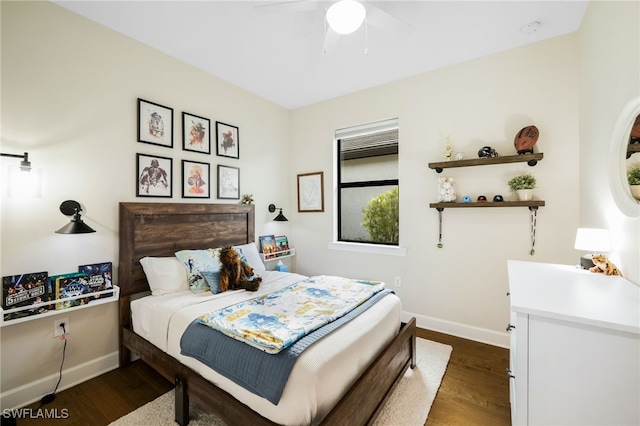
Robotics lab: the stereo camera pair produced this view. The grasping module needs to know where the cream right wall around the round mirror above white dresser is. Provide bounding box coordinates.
[579,1,640,284]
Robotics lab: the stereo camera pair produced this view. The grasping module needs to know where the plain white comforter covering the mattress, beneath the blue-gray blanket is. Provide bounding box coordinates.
[131,271,401,425]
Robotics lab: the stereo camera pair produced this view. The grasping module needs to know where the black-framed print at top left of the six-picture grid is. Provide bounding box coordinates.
[138,98,173,148]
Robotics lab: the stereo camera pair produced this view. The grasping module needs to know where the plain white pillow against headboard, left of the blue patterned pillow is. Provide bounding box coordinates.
[140,257,189,296]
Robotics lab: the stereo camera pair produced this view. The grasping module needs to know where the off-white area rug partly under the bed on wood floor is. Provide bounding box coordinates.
[110,338,452,426]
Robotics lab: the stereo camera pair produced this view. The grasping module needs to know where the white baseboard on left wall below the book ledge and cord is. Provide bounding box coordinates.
[0,351,119,410]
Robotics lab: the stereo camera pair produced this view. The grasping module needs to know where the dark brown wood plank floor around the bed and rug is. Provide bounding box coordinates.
[12,329,511,426]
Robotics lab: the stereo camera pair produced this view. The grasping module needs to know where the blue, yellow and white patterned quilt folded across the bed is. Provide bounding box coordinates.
[198,275,384,354]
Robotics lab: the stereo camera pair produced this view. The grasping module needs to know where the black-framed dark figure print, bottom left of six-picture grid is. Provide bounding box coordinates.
[136,154,173,198]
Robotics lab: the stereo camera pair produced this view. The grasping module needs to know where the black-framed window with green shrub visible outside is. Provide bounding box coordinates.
[336,119,399,246]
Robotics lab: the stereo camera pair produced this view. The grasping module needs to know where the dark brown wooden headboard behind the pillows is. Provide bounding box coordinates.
[118,203,255,297]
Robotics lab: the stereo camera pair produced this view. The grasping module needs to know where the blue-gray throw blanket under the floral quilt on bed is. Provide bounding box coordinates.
[180,289,393,405]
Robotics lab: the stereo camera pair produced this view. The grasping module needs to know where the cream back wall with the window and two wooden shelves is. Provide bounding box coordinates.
[288,34,580,345]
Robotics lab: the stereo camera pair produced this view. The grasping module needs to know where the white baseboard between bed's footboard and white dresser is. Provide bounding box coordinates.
[402,311,509,349]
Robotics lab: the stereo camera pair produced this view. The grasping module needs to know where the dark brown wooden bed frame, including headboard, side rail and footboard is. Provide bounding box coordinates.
[118,203,416,426]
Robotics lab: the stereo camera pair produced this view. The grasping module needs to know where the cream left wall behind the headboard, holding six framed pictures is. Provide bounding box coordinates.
[0,2,290,408]
